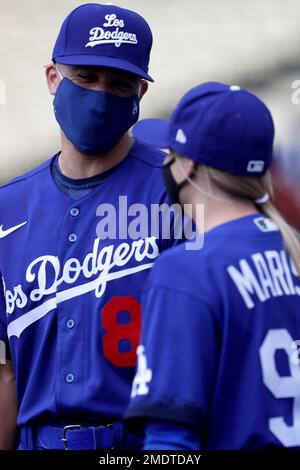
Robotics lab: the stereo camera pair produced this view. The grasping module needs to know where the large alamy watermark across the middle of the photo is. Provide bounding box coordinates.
[96,196,204,250]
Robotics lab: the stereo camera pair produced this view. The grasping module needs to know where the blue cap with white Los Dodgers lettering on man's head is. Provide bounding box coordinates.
[52,3,153,82]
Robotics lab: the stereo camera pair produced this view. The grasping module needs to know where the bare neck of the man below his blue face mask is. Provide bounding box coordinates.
[59,133,133,179]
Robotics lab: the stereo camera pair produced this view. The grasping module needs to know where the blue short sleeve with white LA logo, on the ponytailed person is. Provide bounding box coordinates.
[126,276,218,433]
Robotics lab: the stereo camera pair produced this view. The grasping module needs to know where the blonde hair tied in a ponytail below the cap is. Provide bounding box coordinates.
[206,167,300,276]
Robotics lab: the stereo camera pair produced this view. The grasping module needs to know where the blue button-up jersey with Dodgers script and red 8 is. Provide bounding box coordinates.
[0,143,183,426]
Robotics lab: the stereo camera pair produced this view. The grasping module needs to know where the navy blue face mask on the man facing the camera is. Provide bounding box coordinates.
[53,78,139,155]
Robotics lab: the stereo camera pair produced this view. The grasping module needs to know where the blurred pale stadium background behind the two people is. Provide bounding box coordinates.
[0,0,300,230]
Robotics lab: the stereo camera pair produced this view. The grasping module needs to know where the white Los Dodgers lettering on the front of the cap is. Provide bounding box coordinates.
[85,14,138,47]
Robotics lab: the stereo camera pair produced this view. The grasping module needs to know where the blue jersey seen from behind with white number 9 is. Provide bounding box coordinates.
[126,214,300,449]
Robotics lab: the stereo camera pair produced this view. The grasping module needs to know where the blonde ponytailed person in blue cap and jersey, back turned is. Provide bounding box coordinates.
[127,82,300,450]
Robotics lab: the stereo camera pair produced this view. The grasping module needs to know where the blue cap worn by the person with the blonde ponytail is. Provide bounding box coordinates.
[133,82,274,176]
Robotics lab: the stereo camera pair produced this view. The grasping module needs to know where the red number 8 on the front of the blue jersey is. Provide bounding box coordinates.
[102,296,141,367]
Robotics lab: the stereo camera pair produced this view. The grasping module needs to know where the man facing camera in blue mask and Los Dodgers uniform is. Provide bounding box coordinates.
[0,3,183,450]
